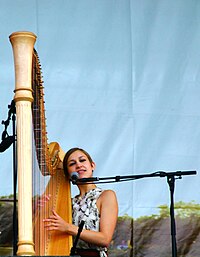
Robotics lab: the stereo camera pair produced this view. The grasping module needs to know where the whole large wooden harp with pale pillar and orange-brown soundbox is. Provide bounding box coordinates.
[9,31,72,256]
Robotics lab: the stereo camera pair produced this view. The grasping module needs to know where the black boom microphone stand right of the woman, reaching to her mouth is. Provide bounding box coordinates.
[76,168,197,257]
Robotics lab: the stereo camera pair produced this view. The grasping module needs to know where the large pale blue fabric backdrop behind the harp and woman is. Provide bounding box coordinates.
[0,0,200,217]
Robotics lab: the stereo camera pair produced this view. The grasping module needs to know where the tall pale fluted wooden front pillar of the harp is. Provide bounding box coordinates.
[9,31,36,255]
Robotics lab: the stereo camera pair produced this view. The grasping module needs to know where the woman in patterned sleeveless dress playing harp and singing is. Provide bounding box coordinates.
[45,148,118,257]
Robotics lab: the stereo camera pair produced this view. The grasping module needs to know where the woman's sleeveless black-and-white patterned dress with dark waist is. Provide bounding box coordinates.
[72,187,107,257]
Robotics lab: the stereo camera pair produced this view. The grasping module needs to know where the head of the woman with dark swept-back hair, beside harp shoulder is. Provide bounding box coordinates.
[67,150,95,178]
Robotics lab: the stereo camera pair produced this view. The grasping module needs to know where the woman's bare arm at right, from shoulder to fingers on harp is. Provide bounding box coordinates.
[44,190,118,247]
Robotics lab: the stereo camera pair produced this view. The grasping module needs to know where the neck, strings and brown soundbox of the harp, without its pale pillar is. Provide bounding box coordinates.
[32,49,72,256]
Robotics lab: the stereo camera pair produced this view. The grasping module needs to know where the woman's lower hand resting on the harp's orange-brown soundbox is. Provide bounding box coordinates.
[43,210,69,233]
